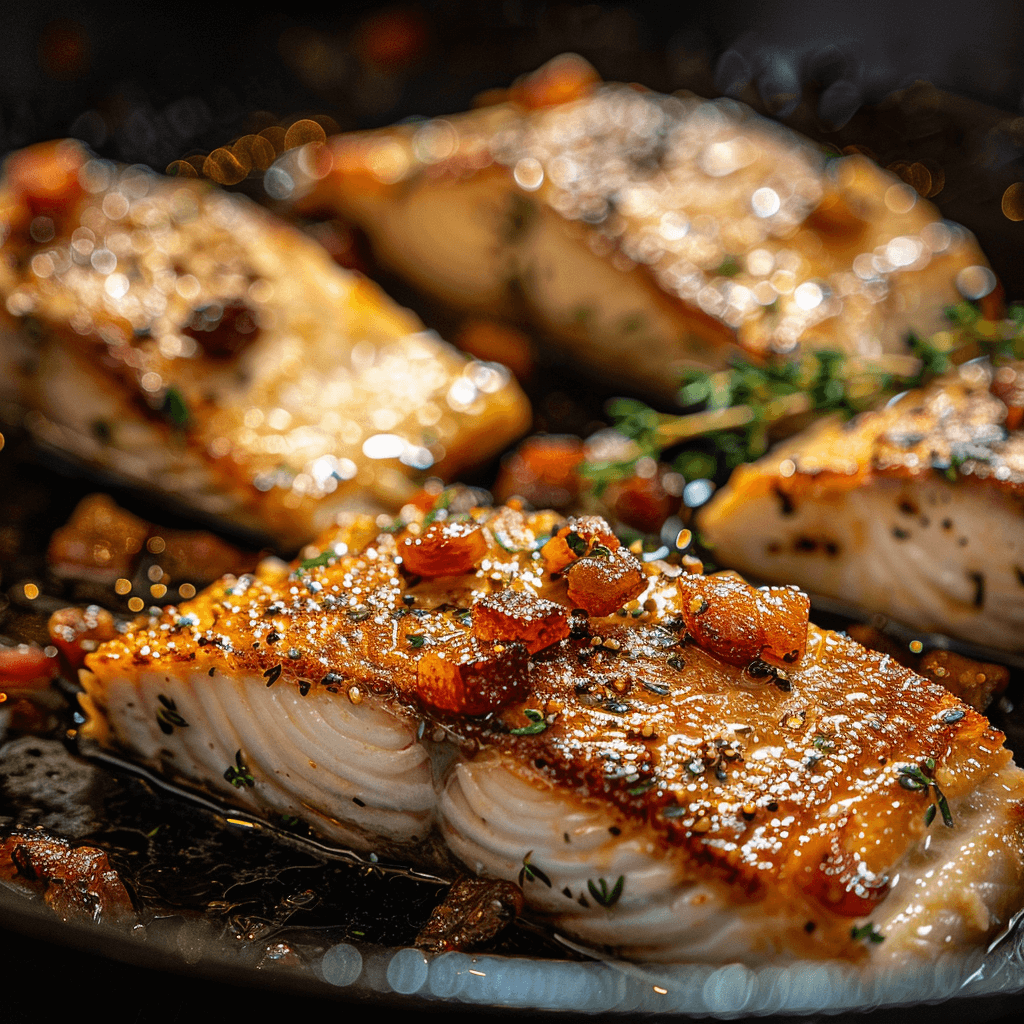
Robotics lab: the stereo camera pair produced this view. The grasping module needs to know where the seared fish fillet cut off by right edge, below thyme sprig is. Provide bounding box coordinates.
[699,361,1024,651]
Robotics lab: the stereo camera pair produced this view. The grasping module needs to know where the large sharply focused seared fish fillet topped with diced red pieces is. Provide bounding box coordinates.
[81,507,1024,963]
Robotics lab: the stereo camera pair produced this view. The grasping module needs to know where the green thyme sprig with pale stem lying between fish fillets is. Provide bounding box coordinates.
[580,301,1024,497]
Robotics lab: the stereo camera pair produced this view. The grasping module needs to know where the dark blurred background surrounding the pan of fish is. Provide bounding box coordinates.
[6,0,1024,1024]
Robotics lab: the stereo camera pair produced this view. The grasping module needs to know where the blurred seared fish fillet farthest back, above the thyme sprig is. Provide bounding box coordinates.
[288,58,997,395]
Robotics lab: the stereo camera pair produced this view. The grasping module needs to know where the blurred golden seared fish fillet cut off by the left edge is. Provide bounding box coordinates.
[0,142,528,545]
